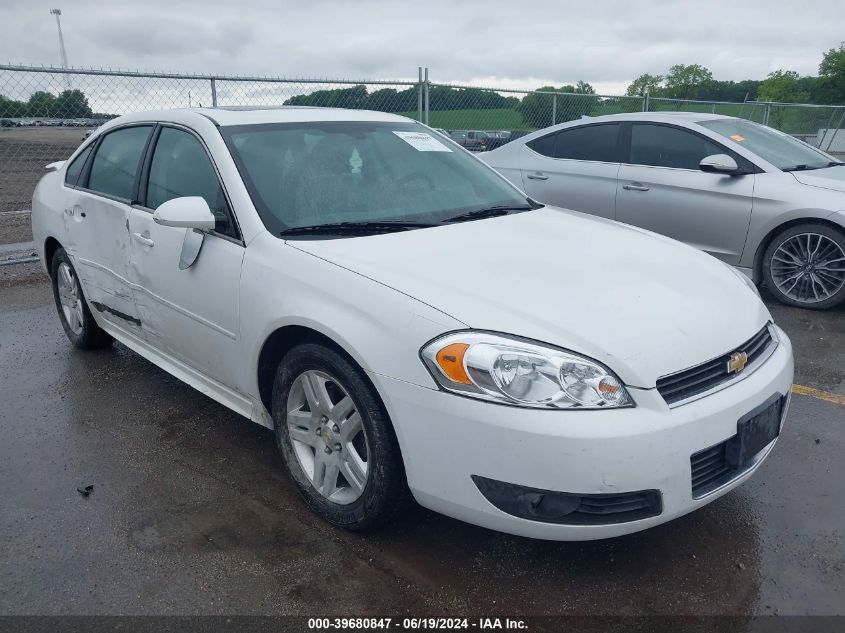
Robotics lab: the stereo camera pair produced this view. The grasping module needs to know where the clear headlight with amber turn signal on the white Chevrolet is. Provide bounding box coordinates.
[421,332,634,409]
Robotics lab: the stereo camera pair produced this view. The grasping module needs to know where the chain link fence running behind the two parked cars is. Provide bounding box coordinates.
[0,65,845,213]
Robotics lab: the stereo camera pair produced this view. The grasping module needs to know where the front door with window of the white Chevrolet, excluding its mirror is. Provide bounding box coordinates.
[128,125,244,386]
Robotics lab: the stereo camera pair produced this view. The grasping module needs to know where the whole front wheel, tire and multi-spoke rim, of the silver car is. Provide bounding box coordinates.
[763,223,845,310]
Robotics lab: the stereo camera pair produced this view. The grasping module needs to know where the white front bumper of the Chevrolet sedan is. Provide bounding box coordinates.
[371,328,793,540]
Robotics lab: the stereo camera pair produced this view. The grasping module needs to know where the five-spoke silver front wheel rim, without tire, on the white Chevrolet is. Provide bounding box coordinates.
[285,370,370,505]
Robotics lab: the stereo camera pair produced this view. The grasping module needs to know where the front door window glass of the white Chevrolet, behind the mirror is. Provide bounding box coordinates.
[146,127,236,237]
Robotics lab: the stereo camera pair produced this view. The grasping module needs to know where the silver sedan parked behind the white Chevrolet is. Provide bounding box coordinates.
[483,113,845,309]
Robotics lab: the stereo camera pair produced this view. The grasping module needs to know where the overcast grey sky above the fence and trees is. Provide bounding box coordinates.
[0,0,845,94]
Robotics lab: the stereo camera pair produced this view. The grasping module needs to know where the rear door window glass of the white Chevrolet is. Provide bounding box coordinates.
[88,126,152,200]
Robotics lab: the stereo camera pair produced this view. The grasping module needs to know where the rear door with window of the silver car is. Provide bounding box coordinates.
[520,123,621,219]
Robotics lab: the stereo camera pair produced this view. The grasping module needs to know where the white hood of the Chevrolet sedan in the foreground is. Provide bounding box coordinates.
[289,207,770,388]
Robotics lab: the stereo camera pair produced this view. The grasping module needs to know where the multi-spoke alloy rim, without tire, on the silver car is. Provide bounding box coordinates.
[770,233,845,303]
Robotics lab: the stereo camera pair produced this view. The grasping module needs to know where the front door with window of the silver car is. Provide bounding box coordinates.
[616,123,755,265]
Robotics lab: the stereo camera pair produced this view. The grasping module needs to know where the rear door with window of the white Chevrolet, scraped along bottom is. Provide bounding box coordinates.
[65,125,153,331]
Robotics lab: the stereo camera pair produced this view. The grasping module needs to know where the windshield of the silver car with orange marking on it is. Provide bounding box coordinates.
[698,119,836,171]
